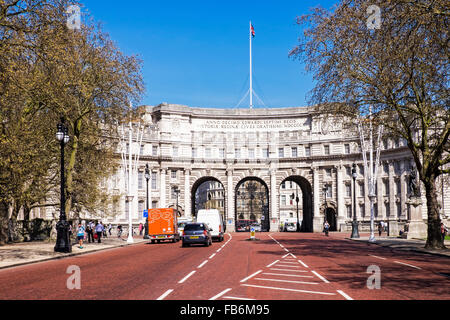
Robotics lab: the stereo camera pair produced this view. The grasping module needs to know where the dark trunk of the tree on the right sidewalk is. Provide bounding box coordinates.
[424,177,445,249]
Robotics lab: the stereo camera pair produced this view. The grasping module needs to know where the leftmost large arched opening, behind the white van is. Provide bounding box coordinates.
[191,177,226,221]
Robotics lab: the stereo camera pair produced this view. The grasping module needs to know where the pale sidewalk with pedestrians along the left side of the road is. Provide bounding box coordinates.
[0,235,148,269]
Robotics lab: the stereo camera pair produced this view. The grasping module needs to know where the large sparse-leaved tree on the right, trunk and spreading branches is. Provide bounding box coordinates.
[290,0,450,248]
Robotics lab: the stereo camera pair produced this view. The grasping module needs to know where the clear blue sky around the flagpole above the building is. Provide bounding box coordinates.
[81,0,336,108]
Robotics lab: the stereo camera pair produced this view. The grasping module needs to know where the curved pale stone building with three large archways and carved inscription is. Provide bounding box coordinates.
[26,103,450,233]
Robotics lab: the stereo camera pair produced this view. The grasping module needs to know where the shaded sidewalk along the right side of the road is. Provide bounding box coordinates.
[345,234,450,257]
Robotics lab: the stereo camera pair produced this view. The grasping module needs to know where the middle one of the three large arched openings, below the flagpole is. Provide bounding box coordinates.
[235,177,270,231]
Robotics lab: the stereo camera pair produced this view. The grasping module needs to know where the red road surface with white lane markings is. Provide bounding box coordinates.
[0,233,450,301]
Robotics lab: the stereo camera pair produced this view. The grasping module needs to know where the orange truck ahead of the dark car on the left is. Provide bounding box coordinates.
[147,208,180,243]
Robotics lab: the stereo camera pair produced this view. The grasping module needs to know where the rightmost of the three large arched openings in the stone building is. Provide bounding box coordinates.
[279,176,313,232]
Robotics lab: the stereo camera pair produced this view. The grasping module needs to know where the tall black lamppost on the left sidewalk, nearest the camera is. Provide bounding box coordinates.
[54,117,72,252]
